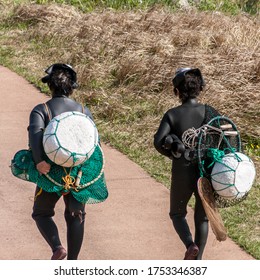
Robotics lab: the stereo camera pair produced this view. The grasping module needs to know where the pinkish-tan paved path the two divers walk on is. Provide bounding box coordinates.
[0,66,252,260]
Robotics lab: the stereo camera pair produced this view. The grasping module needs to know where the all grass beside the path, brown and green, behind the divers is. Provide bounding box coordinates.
[0,0,260,259]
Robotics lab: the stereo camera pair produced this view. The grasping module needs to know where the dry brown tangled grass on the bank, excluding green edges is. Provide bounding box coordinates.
[1,4,260,177]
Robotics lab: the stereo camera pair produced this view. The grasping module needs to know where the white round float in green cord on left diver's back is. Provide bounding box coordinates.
[43,112,98,167]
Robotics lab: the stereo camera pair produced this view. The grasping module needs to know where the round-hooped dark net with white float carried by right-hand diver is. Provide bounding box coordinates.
[196,116,254,208]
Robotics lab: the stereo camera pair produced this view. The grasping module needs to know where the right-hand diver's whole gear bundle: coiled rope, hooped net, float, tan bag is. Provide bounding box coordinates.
[182,116,255,241]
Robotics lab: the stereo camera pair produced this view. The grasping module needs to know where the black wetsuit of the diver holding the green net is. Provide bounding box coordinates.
[28,96,92,260]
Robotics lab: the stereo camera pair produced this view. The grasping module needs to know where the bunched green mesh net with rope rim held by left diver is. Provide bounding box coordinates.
[11,145,108,204]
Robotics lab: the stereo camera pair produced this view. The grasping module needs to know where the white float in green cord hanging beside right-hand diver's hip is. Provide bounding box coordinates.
[211,152,256,199]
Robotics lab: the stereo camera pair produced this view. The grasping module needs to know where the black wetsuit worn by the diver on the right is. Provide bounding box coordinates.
[154,99,219,259]
